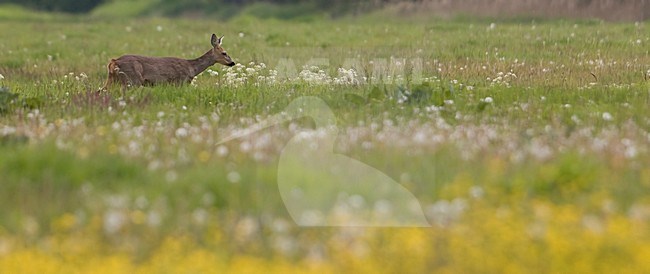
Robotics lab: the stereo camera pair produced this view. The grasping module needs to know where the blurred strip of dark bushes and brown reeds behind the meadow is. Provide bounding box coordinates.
[0,0,650,21]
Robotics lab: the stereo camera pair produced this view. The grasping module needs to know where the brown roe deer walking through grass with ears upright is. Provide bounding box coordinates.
[100,34,235,91]
